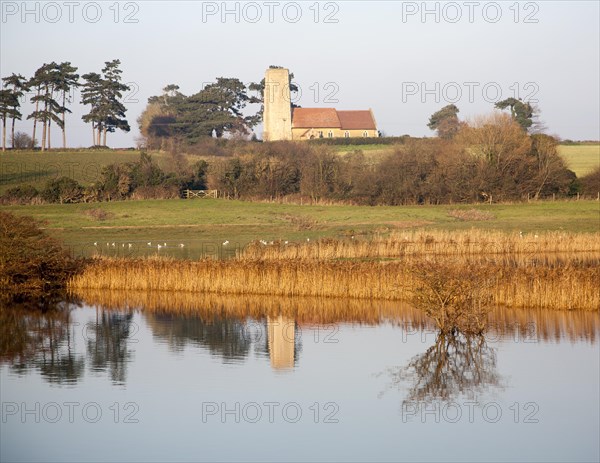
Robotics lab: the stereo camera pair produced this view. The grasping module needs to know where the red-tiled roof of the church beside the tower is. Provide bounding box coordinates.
[292,108,377,130]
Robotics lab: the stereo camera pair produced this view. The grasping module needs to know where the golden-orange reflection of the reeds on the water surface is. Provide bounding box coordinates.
[78,290,600,342]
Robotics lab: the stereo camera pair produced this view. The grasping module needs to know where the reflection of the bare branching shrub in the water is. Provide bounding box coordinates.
[382,334,501,402]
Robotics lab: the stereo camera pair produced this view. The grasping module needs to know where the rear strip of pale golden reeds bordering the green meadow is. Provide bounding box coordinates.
[237,230,600,262]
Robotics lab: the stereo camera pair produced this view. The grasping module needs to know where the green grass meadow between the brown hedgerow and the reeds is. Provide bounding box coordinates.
[2,199,600,258]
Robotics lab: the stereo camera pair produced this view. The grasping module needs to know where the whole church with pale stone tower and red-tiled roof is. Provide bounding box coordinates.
[263,68,379,141]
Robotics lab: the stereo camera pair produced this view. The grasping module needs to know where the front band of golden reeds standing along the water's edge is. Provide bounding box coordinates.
[70,259,600,310]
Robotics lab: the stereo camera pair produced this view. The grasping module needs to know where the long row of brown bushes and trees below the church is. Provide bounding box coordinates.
[2,113,600,205]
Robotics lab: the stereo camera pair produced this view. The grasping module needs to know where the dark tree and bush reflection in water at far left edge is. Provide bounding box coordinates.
[0,306,85,384]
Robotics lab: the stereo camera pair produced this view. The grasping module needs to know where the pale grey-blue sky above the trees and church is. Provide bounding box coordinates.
[0,0,600,147]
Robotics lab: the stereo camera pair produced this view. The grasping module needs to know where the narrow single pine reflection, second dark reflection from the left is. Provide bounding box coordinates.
[85,311,133,383]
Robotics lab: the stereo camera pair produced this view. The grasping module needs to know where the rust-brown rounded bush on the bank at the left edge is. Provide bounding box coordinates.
[0,211,78,305]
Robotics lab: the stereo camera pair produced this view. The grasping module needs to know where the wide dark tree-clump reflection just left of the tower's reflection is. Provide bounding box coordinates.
[148,314,252,360]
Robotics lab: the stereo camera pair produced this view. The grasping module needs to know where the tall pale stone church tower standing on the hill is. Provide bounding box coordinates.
[263,68,292,141]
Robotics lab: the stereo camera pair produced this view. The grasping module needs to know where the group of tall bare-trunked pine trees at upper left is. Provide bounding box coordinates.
[0,59,130,151]
